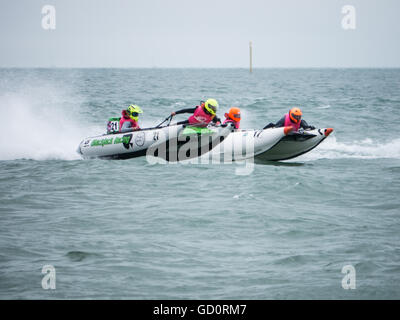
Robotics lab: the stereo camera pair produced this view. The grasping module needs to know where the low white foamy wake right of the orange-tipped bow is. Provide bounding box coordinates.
[297,136,400,161]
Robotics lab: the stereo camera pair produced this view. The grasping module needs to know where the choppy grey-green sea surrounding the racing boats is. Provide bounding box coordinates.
[0,69,400,299]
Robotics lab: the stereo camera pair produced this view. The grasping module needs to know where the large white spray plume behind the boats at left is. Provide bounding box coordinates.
[0,89,104,160]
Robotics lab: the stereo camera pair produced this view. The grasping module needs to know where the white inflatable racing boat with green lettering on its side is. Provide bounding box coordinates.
[77,120,234,161]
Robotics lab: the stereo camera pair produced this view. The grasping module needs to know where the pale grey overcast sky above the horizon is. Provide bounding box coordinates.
[0,0,400,68]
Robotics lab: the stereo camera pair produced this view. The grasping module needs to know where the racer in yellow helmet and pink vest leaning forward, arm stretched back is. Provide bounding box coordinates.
[171,99,221,127]
